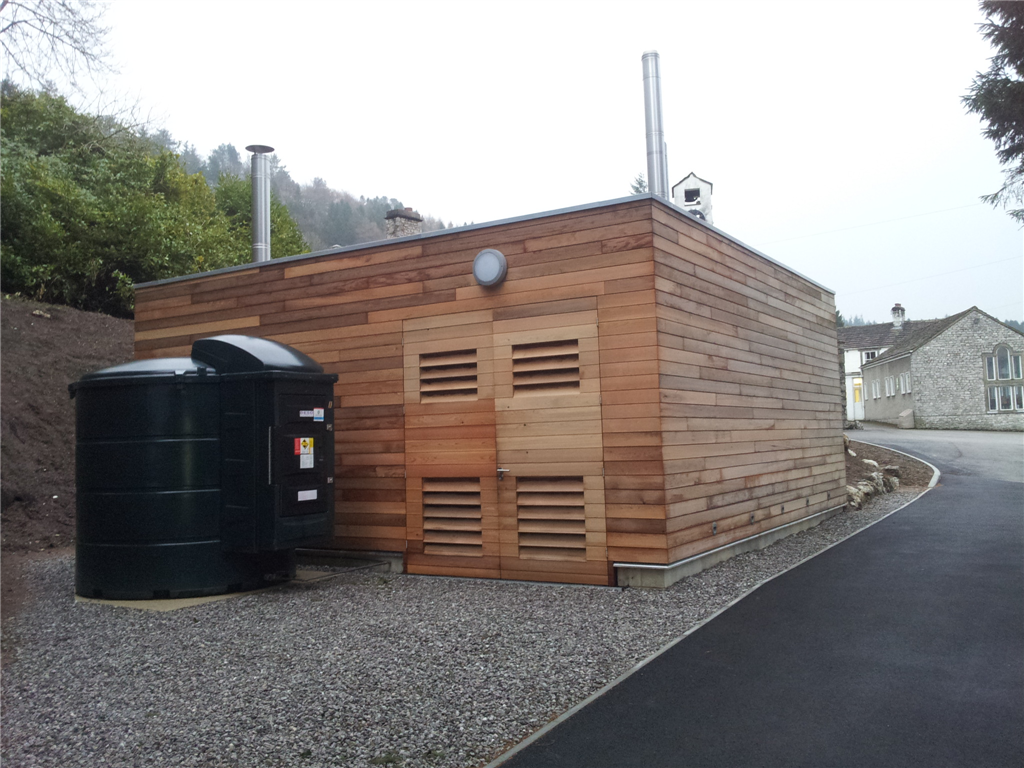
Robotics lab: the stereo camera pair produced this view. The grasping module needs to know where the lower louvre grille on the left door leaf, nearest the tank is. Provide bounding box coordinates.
[423,477,483,557]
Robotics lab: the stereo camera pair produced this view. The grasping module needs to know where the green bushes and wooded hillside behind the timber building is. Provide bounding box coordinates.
[0,86,454,316]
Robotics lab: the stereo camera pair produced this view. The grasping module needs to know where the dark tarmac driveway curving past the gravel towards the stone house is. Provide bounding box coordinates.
[495,427,1024,768]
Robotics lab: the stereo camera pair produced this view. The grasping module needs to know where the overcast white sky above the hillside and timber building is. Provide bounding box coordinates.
[88,0,1024,322]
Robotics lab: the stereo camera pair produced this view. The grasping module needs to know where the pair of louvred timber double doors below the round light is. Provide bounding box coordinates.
[404,312,610,584]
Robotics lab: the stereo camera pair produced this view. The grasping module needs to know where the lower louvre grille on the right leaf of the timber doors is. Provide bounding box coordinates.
[516,477,587,560]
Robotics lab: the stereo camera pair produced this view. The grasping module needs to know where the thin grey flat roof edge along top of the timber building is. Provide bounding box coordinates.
[135,193,836,296]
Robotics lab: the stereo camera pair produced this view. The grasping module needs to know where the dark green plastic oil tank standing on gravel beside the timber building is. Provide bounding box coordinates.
[69,336,337,600]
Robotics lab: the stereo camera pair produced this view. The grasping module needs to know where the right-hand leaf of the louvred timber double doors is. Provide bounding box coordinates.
[494,312,609,584]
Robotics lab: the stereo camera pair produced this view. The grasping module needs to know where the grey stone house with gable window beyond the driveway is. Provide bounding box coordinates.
[864,305,1024,431]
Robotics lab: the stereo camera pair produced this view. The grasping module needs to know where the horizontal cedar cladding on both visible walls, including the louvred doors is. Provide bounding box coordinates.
[135,196,846,584]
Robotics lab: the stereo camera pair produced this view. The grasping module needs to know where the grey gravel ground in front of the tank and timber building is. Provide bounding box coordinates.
[0,489,920,768]
